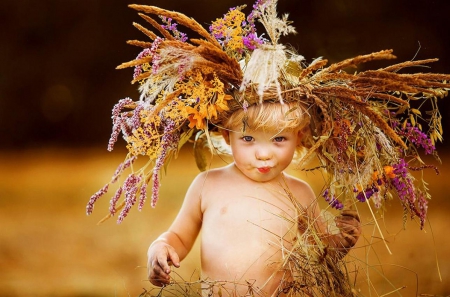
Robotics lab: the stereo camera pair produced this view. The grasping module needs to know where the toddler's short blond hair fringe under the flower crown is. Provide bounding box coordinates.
[223,101,310,131]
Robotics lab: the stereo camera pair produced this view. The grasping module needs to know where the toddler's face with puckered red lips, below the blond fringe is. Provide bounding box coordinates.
[224,129,300,182]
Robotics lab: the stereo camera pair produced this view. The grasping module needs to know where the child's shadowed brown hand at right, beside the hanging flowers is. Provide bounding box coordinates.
[335,210,361,248]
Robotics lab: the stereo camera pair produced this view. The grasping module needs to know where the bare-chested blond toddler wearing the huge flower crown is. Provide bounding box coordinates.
[148,102,361,296]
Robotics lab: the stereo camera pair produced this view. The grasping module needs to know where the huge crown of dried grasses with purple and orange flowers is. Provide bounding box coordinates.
[87,0,450,227]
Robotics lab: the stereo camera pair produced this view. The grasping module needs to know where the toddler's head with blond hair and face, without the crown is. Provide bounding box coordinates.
[217,102,309,182]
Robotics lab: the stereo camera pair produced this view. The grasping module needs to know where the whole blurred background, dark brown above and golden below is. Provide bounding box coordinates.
[0,0,450,296]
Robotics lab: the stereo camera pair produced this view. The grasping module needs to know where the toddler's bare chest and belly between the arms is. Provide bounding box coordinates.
[201,185,296,279]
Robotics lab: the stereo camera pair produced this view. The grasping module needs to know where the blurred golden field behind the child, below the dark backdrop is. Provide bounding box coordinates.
[0,148,450,296]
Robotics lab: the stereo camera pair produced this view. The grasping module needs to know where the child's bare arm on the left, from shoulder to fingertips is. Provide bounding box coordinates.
[147,174,204,286]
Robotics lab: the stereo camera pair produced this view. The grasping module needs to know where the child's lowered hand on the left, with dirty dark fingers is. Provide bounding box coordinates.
[147,241,180,287]
